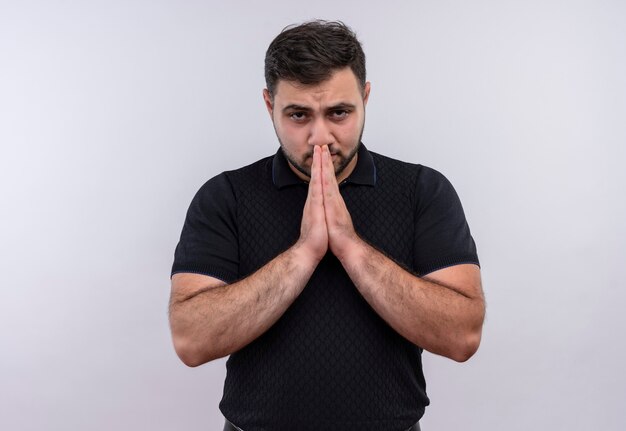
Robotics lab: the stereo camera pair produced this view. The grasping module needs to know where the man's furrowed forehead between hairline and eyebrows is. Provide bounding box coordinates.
[274,67,362,107]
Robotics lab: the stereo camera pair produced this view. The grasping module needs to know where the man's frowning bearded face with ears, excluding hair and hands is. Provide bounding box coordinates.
[263,67,370,182]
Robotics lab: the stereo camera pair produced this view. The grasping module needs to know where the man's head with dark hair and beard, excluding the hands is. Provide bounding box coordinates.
[263,21,370,179]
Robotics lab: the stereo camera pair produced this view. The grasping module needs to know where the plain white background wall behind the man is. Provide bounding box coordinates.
[0,0,626,431]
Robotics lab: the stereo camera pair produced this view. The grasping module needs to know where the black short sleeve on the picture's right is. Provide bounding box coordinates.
[415,166,479,275]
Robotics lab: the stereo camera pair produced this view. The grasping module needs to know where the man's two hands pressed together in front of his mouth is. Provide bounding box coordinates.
[298,145,360,262]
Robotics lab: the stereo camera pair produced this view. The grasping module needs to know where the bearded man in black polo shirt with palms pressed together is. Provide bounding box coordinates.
[170,21,484,431]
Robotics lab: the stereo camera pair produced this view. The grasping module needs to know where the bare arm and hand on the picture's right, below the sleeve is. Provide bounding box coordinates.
[321,148,485,361]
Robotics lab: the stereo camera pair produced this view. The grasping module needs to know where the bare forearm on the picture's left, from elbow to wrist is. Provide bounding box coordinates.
[170,244,316,366]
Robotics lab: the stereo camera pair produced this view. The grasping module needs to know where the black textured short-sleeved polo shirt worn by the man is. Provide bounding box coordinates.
[172,145,478,431]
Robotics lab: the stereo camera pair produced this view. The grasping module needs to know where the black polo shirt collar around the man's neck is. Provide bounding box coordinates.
[272,143,376,189]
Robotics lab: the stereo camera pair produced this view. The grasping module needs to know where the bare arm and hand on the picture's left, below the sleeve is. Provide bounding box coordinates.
[170,147,328,366]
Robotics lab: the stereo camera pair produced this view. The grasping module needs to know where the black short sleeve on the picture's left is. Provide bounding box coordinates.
[172,174,239,283]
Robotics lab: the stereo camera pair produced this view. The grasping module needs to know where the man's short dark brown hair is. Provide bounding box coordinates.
[265,20,365,97]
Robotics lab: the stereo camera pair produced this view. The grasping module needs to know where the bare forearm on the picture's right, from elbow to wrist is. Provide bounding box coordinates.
[340,239,484,361]
